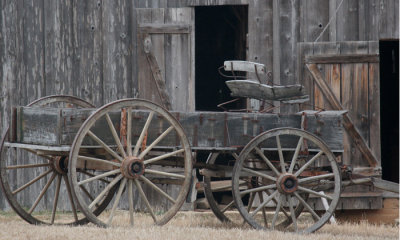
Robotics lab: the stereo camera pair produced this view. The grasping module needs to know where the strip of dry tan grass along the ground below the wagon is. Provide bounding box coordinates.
[0,212,399,240]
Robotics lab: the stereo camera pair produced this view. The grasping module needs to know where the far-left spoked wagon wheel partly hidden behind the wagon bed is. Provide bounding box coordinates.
[0,95,113,224]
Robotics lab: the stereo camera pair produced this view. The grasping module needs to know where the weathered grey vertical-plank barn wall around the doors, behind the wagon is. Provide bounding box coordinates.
[0,0,399,208]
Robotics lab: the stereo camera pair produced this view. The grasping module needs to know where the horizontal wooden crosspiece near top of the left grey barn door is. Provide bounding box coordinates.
[139,23,192,34]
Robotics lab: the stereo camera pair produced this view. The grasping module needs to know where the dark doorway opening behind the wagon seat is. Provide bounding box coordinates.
[195,5,248,111]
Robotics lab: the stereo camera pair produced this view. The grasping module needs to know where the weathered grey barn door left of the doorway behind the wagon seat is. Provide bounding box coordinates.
[136,8,195,111]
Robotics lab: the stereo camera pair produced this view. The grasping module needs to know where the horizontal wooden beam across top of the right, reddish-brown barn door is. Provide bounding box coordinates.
[305,54,379,64]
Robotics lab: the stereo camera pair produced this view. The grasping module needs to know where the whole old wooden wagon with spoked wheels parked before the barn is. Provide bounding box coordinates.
[0,61,394,232]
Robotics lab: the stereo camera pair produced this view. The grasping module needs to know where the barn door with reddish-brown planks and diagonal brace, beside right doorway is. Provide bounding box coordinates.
[299,42,380,174]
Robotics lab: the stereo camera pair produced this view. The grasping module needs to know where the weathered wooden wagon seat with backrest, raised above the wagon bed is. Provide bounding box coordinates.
[224,61,309,103]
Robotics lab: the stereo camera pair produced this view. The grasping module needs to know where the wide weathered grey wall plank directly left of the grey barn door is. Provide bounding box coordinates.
[102,0,132,103]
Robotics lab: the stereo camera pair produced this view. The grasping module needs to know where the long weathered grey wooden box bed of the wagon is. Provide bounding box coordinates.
[9,107,345,152]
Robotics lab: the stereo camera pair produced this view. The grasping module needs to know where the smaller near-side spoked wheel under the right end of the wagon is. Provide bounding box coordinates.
[232,128,341,233]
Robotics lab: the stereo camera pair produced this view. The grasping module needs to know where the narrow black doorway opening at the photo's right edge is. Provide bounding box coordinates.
[379,40,399,183]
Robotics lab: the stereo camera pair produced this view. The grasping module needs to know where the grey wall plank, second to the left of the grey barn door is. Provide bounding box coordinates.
[72,1,104,106]
